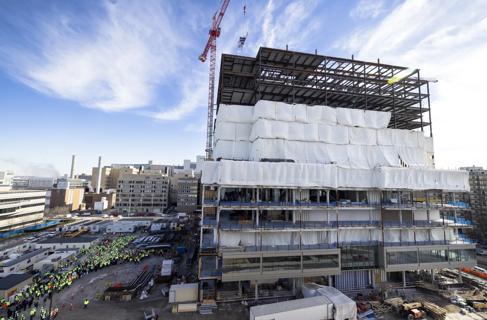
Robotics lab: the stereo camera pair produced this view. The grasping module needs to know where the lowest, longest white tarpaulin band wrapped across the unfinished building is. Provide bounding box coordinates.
[202,160,470,191]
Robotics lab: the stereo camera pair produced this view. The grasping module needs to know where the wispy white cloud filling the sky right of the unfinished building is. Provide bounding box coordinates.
[337,0,487,167]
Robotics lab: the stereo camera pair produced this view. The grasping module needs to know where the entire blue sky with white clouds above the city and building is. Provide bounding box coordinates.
[0,0,487,175]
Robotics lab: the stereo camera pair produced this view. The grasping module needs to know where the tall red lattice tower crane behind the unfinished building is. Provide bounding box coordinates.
[199,0,230,159]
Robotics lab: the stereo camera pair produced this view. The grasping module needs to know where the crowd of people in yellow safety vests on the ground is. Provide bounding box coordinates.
[0,236,149,320]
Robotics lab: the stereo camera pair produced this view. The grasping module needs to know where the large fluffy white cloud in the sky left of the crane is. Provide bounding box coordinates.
[0,1,187,111]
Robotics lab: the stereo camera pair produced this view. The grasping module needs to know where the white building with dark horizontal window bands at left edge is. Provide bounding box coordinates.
[0,189,46,232]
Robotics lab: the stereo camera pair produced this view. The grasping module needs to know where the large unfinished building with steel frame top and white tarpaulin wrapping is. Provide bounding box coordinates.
[199,48,476,301]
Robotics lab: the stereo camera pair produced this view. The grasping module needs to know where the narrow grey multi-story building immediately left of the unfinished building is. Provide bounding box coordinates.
[175,170,200,214]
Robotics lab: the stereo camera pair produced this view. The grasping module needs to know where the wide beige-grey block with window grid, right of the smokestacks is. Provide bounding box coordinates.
[115,167,169,213]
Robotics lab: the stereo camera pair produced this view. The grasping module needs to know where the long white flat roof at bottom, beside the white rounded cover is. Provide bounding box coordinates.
[250,296,333,316]
